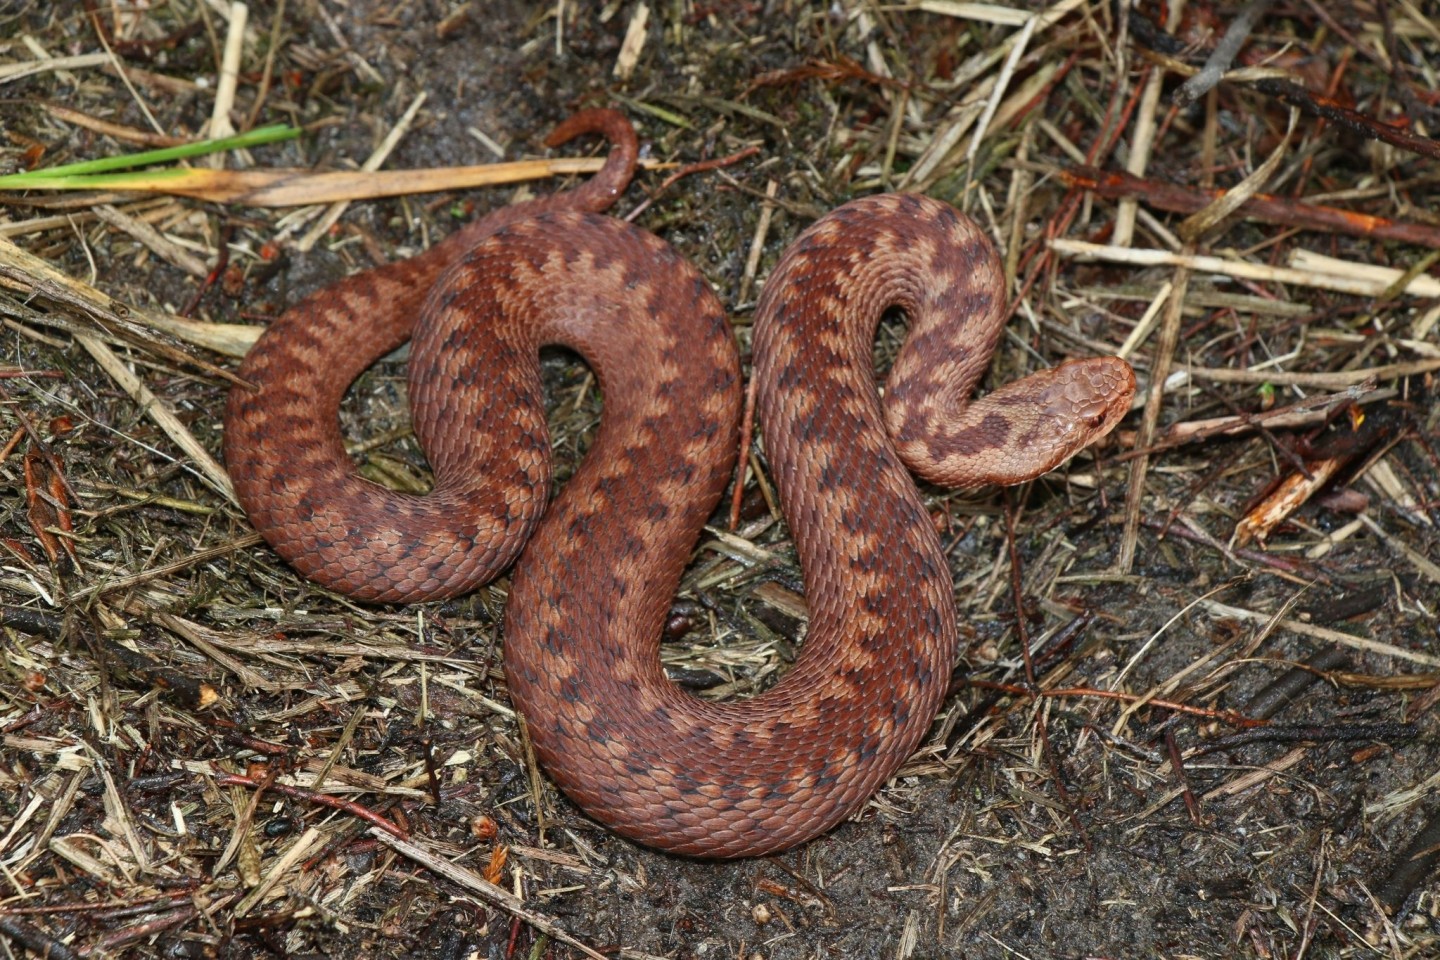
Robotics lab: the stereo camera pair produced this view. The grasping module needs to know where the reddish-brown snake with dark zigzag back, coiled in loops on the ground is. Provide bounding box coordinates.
[225,111,1135,856]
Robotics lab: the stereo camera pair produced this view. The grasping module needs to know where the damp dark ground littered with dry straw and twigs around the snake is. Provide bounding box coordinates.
[0,0,1440,960]
